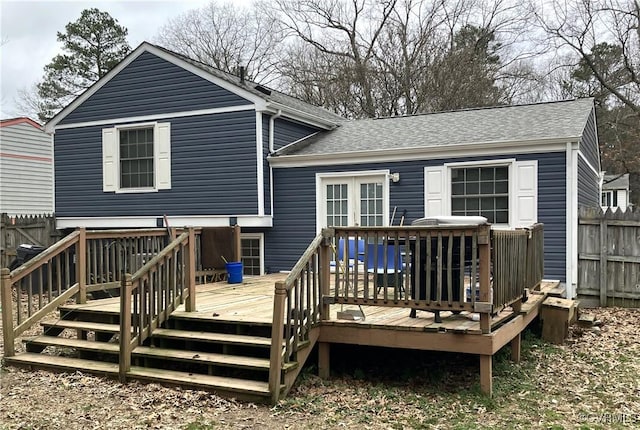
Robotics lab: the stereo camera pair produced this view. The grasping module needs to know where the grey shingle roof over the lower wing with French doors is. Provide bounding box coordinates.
[279,99,593,155]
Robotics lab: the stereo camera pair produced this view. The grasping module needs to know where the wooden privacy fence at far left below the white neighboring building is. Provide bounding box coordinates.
[0,213,62,267]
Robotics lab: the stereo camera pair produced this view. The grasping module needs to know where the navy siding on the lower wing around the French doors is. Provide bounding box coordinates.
[265,152,566,281]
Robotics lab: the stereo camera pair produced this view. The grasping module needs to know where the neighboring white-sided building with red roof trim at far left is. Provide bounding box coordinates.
[0,118,54,216]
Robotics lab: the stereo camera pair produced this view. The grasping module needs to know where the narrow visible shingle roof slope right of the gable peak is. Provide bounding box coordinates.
[153,45,346,124]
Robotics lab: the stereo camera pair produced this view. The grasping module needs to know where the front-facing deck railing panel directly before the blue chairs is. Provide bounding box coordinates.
[331,225,492,328]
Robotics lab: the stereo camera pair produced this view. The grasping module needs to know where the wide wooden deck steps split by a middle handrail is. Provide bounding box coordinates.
[5,305,300,403]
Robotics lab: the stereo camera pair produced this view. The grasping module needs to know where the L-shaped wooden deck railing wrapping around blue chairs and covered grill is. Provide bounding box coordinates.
[326,224,543,333]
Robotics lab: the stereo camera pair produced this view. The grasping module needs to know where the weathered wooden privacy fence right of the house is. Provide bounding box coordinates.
[577,208,640,307]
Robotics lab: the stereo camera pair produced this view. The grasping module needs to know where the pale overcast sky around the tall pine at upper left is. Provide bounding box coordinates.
[0,0,238,118]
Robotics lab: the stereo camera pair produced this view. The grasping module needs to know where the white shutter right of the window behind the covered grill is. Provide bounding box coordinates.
[511,160,538,227]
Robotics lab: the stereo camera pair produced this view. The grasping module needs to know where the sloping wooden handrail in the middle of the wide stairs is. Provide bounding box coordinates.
[119,229,196,382]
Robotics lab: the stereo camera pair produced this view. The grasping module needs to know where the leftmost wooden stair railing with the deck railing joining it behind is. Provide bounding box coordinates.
[0,228,188,357]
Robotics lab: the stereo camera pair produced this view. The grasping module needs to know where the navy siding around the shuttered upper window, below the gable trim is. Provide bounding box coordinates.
[54,111,258,217]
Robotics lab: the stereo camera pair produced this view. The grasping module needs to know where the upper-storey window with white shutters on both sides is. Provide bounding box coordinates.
[102,123,171,192]
